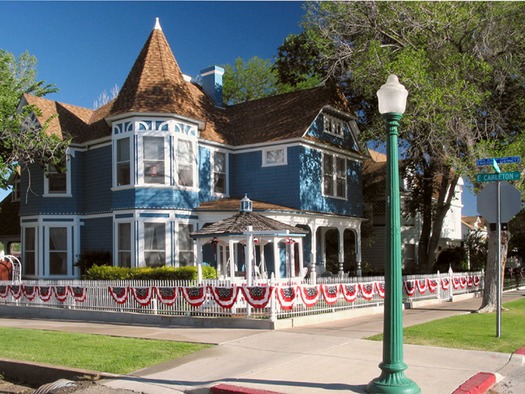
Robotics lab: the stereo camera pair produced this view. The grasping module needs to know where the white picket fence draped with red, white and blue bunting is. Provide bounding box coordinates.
[0,272,483,320]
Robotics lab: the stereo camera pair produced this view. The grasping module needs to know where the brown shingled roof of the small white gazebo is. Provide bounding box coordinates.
[191,211,308,238]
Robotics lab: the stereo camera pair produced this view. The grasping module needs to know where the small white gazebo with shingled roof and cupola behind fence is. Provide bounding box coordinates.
[191,195,308,285]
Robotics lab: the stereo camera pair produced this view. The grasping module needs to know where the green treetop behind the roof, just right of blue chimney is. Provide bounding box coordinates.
[223,56,320,105]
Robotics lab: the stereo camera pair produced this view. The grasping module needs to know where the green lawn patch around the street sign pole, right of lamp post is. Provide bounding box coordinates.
[369,299,525,353]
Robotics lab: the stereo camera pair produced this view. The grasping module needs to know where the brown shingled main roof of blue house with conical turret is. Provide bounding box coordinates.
[21,20,353,146]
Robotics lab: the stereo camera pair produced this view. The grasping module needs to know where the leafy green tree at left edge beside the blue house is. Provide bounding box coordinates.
[0,49,69,188]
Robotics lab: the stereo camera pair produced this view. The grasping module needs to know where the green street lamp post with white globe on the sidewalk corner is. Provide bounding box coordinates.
[367,75,421,394]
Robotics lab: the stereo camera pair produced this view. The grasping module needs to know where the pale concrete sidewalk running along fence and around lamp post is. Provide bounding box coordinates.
[0,291,525,394]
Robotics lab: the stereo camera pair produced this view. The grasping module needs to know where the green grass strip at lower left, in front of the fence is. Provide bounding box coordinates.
[0,328,210,374]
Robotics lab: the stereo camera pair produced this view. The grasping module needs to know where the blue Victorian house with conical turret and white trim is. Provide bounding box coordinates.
[4,21,365,278]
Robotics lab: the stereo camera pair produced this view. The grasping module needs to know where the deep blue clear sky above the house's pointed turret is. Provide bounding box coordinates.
[0,1,475,215]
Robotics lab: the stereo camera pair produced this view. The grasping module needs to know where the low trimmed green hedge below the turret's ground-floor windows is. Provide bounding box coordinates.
[85,265,217,280]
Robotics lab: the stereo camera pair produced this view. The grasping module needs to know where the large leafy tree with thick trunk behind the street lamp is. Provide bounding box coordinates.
[276,2,525,278]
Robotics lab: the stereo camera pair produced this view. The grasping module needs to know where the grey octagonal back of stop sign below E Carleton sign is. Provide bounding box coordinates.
[477,182,521,223]
